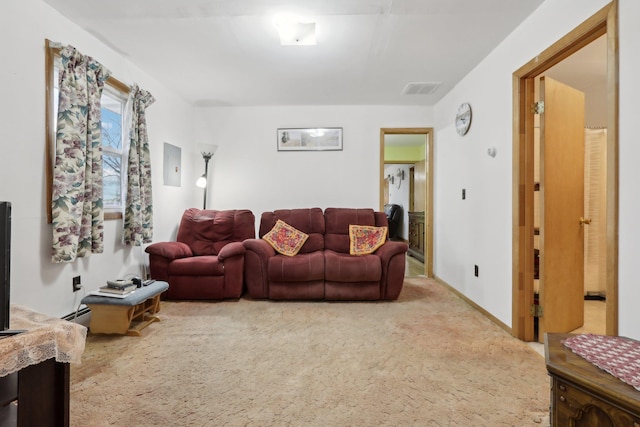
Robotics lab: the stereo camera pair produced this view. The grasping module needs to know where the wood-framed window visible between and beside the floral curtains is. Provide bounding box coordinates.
[45,40,129,223]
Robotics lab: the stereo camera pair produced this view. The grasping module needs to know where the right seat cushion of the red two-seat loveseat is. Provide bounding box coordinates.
[324,250,382,282]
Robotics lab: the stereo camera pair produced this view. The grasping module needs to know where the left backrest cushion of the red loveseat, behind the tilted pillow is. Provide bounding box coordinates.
[258,208,324,255]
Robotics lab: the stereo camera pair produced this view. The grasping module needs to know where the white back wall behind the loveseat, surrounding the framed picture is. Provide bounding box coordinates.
[196,106,432,232]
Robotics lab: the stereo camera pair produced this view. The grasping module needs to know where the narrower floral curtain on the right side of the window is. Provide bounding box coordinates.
[122,85,155,246]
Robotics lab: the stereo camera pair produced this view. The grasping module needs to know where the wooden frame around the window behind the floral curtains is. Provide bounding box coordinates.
[45,39,131,224]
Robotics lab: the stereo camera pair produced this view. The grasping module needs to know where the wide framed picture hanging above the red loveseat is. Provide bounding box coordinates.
[278,128,342,151]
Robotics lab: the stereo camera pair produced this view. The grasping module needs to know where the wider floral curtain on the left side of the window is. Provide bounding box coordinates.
[51,46,111,262]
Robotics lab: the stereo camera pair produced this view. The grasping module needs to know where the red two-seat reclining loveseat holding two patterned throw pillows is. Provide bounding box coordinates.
[243,208,408,300]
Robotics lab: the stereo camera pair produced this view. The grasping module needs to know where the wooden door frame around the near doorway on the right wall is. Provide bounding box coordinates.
[511,0,618,341]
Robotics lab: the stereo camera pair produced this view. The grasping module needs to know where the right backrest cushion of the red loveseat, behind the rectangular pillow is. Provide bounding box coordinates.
[324,208,380,254]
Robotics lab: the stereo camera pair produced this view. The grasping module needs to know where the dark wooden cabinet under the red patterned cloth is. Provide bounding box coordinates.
[545,334,640,427]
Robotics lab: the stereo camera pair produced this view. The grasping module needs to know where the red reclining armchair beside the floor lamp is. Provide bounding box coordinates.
[145,208,255,300]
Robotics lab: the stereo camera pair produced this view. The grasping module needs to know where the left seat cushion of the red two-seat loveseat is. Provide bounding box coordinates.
[267,251,324,282]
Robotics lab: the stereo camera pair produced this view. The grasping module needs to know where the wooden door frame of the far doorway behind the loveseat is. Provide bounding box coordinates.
[380,128,433,277]
